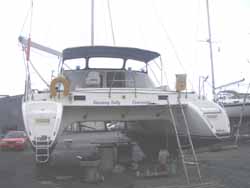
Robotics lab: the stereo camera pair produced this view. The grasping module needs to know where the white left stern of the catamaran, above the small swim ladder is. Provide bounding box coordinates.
[22,101,63,147]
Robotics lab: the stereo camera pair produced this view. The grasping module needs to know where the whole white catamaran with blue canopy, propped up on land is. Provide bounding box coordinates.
[19,1,230,163]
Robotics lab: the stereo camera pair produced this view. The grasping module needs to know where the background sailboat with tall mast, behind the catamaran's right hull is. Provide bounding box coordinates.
[206,0,250,138]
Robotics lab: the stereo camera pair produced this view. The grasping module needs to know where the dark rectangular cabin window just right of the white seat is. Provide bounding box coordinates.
[107,71,126,87]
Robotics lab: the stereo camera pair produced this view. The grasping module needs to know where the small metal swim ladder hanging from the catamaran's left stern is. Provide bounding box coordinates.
[35,136,50,163]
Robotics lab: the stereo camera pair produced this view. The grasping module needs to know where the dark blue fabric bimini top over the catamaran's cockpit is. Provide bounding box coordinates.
[63,46,160,63]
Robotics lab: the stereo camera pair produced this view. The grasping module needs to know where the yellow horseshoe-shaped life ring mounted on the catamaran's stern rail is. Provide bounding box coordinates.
[50,76,69,97]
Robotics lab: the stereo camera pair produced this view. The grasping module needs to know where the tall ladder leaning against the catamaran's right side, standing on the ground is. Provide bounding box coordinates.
[167,93,201,184]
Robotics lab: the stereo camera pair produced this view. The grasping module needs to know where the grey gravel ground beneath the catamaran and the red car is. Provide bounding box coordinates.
[0,144,250,188]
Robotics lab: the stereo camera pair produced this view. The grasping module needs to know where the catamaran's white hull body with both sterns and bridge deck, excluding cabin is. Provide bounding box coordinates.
[23,89,230,162]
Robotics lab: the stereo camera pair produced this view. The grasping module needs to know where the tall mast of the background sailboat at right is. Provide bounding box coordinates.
[206,0,215,99]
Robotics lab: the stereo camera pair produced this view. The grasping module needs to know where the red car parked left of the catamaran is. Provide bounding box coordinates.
[0,131,28,150]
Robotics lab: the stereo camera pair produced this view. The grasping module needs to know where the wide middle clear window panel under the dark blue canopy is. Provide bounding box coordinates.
[89,57,123,69]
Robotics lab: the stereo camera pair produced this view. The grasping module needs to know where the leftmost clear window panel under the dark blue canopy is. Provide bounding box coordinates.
[63,58,86,70]
